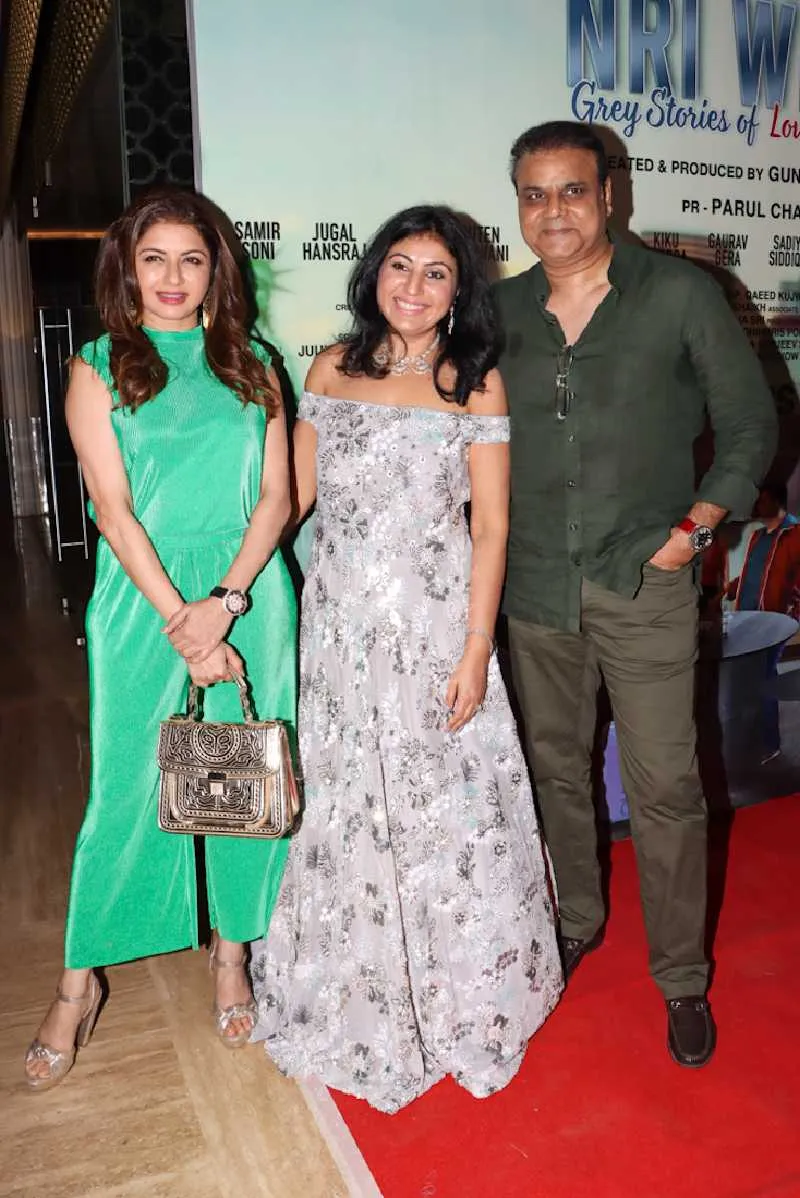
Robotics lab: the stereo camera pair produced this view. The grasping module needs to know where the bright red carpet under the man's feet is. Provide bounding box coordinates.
[334,795,800,1198]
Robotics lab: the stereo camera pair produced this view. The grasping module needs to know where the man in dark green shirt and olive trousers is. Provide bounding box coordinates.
[496,121,776,1066]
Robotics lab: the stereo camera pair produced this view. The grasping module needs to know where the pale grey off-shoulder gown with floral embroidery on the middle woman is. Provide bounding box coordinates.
[253,393,562,1112]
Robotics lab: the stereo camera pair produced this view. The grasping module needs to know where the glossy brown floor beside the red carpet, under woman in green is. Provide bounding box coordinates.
[0,521,349,1198]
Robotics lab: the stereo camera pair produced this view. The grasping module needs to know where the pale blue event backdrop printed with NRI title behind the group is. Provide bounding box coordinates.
[189,0,800,462]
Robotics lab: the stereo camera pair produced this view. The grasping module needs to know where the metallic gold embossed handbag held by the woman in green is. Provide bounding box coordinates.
[158,676,301,840]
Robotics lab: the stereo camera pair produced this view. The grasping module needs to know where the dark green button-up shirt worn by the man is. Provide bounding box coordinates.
[496,233,776,630]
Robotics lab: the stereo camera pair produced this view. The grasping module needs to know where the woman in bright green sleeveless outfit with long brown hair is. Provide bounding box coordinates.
[25,189,296,1089]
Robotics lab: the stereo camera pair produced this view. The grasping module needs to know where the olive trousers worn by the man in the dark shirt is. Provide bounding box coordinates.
[509,565,708,998]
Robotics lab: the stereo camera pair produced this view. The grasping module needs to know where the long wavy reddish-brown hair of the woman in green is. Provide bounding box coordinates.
[95,187,279,415]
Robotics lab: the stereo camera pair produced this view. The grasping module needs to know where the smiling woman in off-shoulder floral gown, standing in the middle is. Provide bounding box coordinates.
[253,207,562,1112]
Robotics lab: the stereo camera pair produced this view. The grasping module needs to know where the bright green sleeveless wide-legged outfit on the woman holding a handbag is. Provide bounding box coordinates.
[65,327,297,969]
